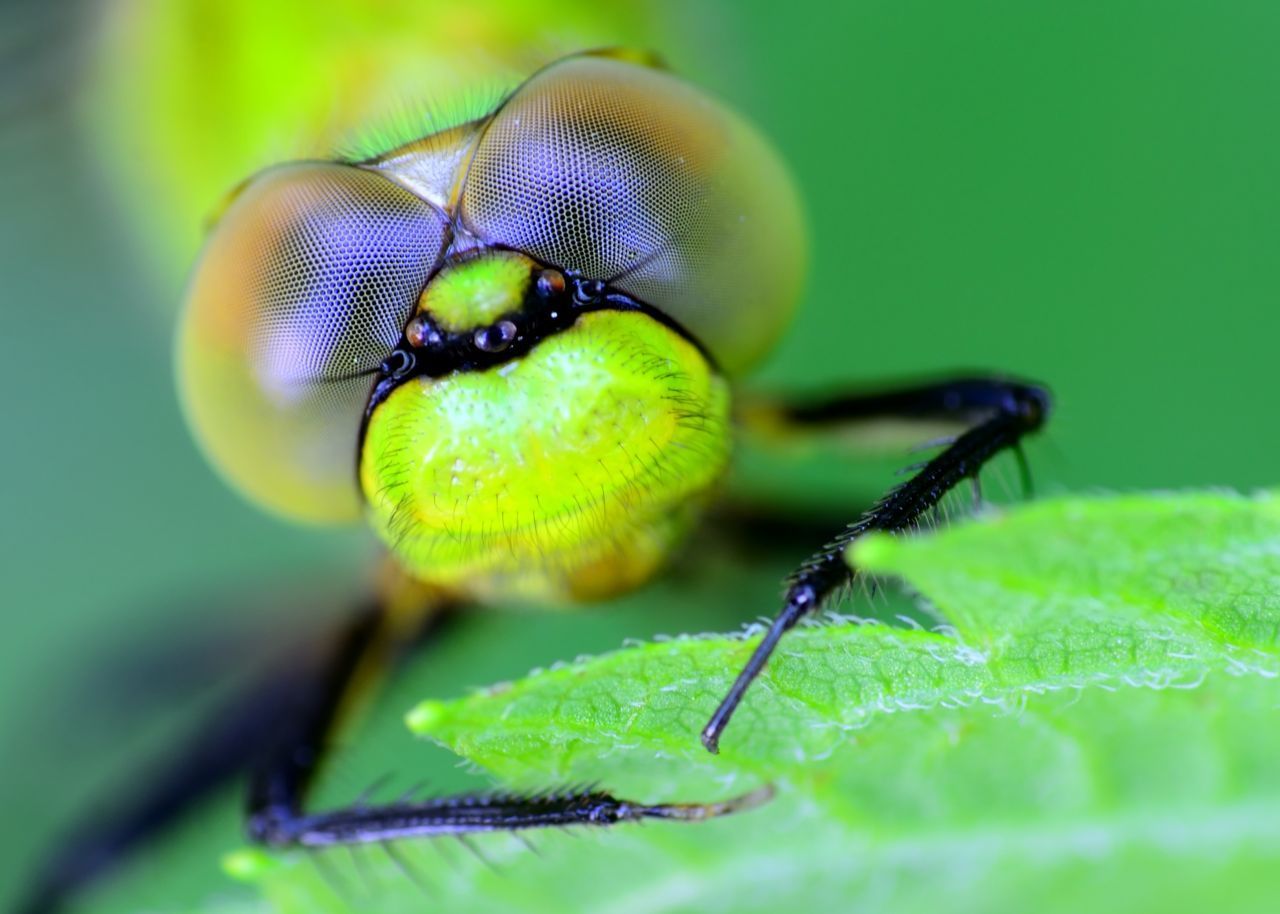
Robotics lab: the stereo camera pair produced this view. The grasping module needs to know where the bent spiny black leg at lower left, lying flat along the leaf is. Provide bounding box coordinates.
[248,591,771,847]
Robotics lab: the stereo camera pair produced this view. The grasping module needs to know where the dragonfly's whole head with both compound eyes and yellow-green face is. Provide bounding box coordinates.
[179,55,804,598]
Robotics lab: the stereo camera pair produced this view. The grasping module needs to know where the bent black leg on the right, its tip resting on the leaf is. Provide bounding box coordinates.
[703,378,1050,753]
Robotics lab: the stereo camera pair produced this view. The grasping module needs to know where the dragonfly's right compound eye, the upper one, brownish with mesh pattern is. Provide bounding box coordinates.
[460,55,805,373]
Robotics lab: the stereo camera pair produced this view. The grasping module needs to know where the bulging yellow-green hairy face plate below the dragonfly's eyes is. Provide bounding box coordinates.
[360,261,730,599]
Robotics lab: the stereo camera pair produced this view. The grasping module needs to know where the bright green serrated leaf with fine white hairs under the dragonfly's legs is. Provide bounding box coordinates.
[237,493,1280,911]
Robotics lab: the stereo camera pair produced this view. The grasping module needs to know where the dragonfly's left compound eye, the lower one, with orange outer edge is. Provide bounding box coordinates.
[178,163,447,521]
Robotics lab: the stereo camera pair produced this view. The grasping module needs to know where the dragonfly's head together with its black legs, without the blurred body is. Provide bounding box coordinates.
[22,50,1051,910]
